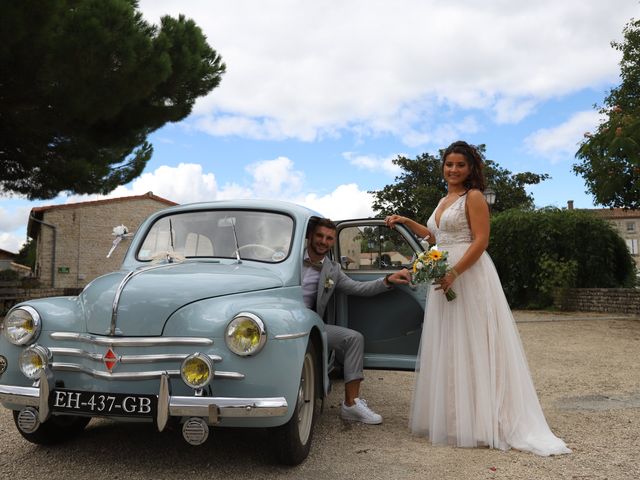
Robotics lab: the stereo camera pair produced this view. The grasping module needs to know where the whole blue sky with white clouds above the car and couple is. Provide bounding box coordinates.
[0,0,640,252]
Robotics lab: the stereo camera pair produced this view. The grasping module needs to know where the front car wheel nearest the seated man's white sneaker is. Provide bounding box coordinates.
[274,342,319,465]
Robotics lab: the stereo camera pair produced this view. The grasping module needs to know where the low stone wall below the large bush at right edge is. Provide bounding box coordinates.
[555,288,640,315]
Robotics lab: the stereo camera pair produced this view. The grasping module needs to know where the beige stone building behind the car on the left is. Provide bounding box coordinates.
[27,192,177,289]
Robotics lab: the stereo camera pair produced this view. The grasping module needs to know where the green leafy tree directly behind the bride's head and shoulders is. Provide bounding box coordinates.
[369,145,549,223]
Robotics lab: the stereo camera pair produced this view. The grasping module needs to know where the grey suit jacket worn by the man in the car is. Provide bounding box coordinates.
[316,257,389,317]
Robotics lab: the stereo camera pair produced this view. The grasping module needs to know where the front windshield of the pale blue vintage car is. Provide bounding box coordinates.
[137,210,293,263]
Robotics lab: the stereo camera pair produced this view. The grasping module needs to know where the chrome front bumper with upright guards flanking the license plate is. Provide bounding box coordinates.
[0,370,288,431]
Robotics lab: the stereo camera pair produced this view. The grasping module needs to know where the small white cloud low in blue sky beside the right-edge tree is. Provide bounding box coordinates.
[524,111,601,163]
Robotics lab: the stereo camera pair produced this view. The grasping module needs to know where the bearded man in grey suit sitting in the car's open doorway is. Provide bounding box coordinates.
[302,218,411,425]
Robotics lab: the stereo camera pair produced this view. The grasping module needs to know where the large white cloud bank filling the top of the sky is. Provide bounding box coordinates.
[140,0,637,146]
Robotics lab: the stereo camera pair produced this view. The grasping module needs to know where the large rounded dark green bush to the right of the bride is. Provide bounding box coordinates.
[489,209,635,308]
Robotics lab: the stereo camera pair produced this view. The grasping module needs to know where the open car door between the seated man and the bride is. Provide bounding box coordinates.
[332,219,427,370]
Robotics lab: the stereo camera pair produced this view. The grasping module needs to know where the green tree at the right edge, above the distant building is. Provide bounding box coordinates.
[573,20,640,208]
